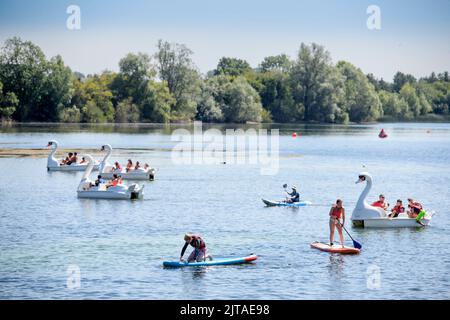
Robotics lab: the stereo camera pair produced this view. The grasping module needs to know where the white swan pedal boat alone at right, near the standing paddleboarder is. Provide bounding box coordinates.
[351,172,432,228]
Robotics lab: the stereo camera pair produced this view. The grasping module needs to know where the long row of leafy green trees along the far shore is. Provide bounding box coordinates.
[0,37,450,123]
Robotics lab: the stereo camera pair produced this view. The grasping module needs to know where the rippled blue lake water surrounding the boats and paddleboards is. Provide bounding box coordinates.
[0,124,450,299]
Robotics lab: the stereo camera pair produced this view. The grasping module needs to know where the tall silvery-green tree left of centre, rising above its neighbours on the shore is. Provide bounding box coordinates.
[155,40,201,120]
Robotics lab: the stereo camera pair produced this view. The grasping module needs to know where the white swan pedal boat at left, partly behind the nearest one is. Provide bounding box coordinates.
[99,144,155,180]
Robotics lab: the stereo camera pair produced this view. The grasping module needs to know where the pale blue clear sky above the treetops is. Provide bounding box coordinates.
[0,0,450,80]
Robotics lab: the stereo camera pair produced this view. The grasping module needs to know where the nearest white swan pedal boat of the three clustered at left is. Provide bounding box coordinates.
[77,155,144,200]
